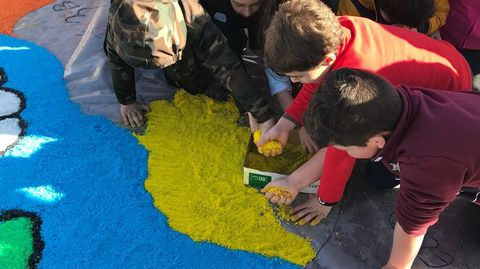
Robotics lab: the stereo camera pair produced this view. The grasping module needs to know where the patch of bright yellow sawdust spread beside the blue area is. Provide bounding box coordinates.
[138,91,315,265]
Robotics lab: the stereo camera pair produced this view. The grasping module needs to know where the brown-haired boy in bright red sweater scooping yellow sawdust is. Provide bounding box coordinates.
[259,0,472,224]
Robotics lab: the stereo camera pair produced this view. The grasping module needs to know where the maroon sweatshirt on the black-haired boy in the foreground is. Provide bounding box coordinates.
[373,86,480,234]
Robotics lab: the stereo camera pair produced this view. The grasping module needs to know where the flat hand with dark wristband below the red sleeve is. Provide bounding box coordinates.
[291,195,332,226]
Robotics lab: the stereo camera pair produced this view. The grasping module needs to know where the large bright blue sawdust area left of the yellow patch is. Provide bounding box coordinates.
[0,35,298,269]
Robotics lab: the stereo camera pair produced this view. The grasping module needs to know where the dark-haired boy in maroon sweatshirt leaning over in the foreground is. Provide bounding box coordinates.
[304,68,480,269]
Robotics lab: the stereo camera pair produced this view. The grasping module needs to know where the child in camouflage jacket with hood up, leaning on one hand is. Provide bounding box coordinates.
[104,0,274,131]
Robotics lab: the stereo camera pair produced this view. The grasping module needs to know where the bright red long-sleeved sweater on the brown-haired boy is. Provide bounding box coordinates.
[286,16,472,203]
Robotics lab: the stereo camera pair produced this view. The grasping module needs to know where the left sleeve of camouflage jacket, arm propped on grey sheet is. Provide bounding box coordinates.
[104,26,136,105]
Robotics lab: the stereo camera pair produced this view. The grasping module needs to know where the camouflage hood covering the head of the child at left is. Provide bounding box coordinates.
[108,0,187,68]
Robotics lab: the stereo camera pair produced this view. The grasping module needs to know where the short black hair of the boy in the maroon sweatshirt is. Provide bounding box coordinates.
[303,68,402,147]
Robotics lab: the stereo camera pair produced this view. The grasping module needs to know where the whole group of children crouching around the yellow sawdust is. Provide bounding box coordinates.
[105,0,480,268]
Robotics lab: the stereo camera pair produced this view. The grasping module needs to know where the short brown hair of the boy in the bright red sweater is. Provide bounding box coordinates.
[264,0,342,73]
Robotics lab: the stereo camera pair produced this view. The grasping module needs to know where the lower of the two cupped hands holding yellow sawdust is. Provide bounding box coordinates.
[261,178,298,205]
